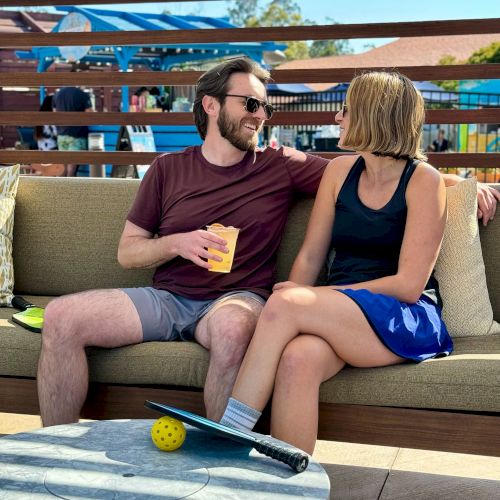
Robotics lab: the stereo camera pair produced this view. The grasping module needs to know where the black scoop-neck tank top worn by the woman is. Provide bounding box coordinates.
[328,156,441,306]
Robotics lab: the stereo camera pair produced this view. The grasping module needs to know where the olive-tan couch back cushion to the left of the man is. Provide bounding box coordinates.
[13,176,153,295]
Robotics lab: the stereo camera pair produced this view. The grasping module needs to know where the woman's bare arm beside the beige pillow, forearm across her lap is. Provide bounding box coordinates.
[329,163,446,303]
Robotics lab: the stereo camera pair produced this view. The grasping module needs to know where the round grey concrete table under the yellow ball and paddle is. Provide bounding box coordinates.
[0,420,330,500]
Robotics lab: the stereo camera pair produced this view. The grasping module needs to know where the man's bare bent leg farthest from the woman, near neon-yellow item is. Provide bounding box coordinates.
[37,290,142,426]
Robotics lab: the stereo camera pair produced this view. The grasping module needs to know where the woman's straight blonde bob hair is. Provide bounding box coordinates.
[341,71,427,160]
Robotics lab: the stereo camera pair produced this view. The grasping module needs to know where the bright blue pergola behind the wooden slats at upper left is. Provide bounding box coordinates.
[16,6,286,111]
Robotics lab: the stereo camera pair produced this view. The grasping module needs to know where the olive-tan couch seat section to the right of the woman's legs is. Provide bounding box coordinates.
[320,335,500,412]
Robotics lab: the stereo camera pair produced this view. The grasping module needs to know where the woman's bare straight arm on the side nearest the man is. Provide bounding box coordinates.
[289,157,353,285]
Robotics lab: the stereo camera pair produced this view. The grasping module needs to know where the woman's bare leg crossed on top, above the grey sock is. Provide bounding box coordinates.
[232,287,403,411]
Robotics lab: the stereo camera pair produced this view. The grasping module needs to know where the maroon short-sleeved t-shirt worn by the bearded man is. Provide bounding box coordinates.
[128,146,328,300]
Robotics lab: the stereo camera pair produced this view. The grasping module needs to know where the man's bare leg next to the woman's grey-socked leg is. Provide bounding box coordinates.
[195,297,262,422]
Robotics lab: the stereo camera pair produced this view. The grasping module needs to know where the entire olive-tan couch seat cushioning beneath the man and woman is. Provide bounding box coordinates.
[0,296,500,412]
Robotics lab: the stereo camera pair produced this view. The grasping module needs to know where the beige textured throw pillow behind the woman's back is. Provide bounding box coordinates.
[436,179,500,337]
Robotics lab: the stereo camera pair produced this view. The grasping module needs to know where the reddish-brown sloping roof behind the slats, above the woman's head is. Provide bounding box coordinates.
[276,34,500,90]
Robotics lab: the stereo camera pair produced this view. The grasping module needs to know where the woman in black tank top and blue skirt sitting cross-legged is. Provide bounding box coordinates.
[221,72,453,453]
